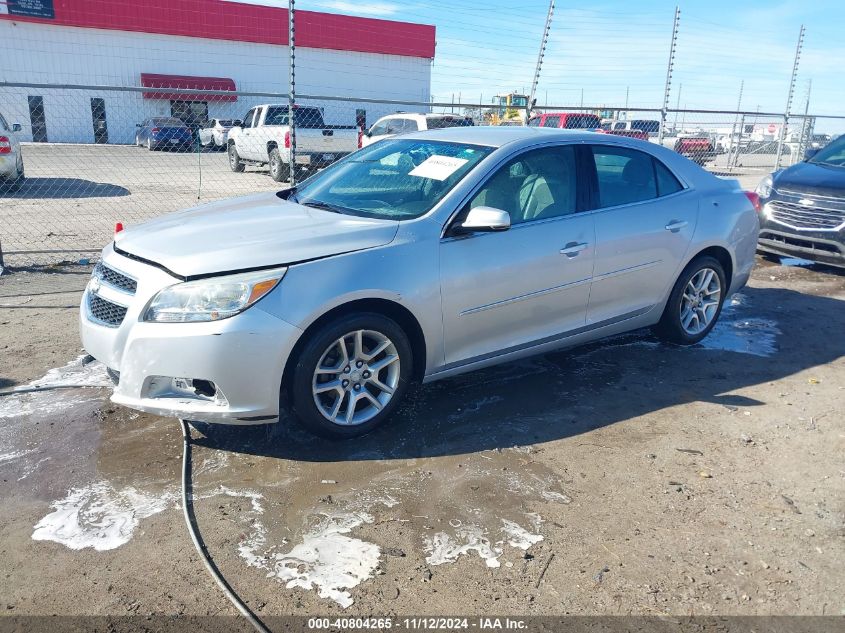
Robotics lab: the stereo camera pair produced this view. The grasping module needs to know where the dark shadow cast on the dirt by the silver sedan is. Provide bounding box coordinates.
[191,288,845,462]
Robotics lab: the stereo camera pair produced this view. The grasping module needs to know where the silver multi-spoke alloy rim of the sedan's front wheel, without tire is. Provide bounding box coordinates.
[311,330,401,426]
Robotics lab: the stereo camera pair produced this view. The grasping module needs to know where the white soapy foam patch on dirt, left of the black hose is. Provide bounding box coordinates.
[32,481,175,552]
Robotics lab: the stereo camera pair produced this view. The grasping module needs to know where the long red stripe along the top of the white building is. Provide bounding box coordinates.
[0,0,435,58]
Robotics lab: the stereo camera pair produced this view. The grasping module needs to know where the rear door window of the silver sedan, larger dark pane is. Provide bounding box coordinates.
[592,145,657,208]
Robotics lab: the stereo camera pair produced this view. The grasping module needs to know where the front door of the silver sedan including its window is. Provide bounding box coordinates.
[440,145,595,364]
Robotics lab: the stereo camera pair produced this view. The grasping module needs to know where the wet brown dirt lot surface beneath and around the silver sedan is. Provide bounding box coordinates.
[0,261,845,616]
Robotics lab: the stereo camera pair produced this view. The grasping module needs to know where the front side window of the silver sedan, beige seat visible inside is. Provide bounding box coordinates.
[469,145,577,225]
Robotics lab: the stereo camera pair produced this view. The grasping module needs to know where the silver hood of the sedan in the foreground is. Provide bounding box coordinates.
[115,193,399,278]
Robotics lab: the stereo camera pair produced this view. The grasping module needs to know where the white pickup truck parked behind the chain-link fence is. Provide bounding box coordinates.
[227,104,361,182]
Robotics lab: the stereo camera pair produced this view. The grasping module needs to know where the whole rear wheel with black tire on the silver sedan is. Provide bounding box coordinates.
[653,256,728,345]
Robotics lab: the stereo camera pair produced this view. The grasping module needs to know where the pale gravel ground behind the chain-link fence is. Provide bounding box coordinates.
[0,143,774,266]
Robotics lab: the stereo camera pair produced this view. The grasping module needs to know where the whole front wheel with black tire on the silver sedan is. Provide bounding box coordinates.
[289,312,413,439]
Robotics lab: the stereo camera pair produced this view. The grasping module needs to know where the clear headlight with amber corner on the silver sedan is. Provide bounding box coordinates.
[144,268,287,323]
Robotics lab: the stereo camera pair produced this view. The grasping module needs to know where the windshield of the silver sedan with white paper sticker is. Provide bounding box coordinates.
[288,139,494,220]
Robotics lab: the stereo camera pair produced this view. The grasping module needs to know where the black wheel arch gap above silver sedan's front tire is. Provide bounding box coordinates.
[282,298,426,390]
